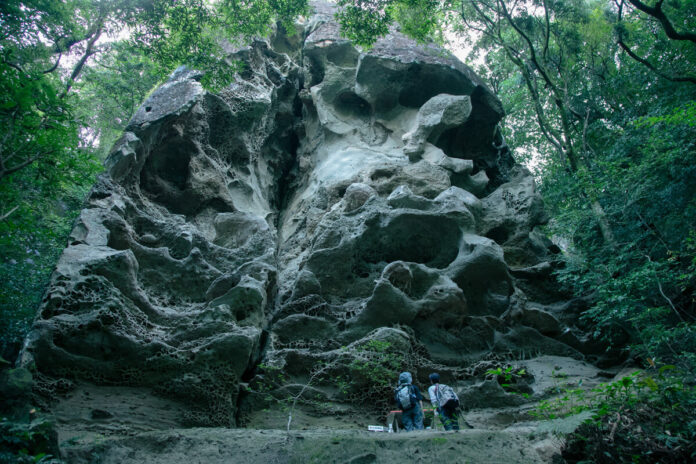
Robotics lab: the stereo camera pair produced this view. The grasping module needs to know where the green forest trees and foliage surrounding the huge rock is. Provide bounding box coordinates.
[0,0,696,457]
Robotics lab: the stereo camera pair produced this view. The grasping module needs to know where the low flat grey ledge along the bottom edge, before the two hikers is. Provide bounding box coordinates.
[63,428,572,464]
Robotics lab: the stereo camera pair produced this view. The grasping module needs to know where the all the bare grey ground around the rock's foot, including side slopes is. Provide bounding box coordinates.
[52,356,620,464]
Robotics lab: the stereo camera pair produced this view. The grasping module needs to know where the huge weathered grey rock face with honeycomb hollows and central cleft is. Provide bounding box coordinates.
[23,0,600,425]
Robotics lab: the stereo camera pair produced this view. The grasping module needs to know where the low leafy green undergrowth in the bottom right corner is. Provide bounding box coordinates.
[535,365,696,464]
